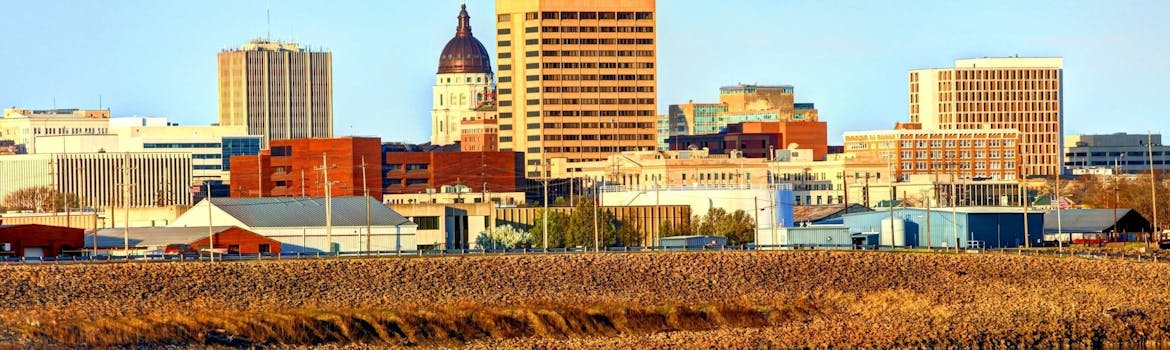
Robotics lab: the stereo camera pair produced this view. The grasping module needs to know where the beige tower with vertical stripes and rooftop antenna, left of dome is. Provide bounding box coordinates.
[219,40,333,149]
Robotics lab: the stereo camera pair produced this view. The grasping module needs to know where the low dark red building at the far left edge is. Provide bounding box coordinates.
[0,224,85,258]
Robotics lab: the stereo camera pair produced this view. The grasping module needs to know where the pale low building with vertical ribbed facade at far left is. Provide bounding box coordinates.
[0,152,194,208]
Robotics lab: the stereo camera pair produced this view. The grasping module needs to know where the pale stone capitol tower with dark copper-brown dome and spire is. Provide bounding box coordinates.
[431,5,491,145]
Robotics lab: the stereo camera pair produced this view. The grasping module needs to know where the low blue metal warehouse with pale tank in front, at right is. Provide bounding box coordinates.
[844,207,1044,248]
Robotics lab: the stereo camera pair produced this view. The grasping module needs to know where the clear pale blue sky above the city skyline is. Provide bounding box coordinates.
[0,0,1170,143]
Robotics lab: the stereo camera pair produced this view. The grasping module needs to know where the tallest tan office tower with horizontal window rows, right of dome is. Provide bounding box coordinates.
[496,0,658,178]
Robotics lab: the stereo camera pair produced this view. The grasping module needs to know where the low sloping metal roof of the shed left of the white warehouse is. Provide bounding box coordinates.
[85,226,234,248]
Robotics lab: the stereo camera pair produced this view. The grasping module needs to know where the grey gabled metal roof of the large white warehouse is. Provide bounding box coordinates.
[212,197,414,227]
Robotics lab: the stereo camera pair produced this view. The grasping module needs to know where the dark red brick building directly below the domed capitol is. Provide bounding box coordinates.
[384,151,524,194]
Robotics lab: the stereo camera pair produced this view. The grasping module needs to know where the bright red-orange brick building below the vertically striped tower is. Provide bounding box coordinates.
[223,137,383,198]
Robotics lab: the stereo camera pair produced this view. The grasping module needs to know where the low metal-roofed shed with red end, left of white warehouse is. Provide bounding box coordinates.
[85,226,281,255]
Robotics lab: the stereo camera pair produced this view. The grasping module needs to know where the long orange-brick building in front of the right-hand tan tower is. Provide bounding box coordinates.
[845,129,1024,180]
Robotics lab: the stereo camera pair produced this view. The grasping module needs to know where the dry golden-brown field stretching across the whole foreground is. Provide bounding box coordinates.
[0,252,1170,349]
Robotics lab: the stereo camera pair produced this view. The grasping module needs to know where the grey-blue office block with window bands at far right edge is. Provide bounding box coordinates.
[1065,133,1170,174]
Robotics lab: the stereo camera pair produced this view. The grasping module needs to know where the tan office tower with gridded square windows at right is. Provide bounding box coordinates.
[910,57,1064,177]
